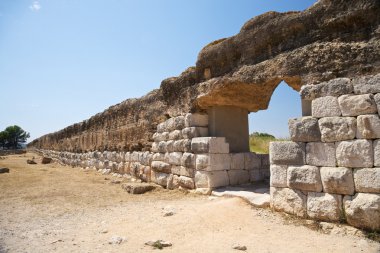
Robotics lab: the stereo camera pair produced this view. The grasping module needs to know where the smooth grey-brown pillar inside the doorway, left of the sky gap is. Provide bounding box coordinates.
[208,106,249,153]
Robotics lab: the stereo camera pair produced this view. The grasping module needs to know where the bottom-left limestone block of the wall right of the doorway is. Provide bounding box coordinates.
[270,187,307,217]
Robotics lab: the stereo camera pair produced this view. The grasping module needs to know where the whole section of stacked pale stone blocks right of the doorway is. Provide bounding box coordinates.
[270,74,380,230]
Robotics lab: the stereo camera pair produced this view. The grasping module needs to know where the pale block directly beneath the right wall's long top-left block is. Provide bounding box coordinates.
[311,96,342,118]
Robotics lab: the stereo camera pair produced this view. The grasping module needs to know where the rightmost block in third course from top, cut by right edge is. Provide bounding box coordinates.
[356,114,380,139]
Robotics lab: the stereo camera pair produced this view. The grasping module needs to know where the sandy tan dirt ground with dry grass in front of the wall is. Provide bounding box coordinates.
[0,153,380,253]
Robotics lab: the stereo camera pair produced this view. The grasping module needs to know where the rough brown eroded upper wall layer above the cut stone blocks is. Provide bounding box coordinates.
[29,0,380,151]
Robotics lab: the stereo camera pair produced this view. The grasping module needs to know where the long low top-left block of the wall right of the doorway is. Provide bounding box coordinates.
[300,78,354,100]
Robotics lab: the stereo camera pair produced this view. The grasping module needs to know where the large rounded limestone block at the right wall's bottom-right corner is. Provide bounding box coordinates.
[343,193,380,230]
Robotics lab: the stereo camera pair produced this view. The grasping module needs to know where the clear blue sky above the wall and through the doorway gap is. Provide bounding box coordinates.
[0,0,315,140]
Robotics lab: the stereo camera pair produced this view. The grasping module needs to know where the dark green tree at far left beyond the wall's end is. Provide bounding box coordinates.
[0,125,30,149]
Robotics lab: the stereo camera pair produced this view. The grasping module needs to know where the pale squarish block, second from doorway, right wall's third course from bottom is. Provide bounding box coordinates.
[306,142,336,167]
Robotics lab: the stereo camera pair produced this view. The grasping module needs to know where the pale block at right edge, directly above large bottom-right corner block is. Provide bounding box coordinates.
[354,168,380,193]
